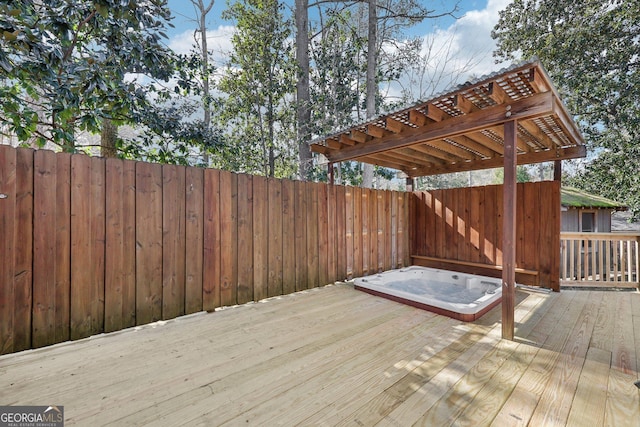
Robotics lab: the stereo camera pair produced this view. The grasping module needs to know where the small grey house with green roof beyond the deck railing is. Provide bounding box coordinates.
[560,187,627,233]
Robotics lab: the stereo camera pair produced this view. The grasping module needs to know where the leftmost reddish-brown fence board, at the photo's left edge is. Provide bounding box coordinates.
[0,145,16,354]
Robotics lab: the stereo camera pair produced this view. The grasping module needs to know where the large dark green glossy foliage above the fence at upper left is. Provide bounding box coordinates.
[0,0,221,159]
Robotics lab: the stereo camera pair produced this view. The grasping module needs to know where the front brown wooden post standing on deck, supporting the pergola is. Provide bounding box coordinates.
[502,120,518,340]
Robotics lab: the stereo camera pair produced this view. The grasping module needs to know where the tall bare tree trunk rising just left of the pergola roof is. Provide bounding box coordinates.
[295,0,312,180]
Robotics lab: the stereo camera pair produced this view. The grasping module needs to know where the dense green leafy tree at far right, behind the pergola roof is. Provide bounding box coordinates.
[492,0,640,219]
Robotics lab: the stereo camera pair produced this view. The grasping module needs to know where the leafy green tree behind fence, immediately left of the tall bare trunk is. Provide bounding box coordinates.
[218,0,295,176]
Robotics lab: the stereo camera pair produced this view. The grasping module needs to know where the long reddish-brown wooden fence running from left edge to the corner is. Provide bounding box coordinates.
[0,146,409,353]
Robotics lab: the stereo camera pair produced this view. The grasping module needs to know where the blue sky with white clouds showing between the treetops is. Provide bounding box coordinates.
[168,0,511,85]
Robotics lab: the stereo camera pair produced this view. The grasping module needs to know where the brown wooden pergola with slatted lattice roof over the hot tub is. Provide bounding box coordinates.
[311,60,586,339]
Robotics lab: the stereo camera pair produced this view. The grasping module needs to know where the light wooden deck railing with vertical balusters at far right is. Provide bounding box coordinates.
[560,232,640,286]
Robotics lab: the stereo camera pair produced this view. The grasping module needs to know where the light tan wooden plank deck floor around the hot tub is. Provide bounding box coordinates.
[0,285,640,426]
